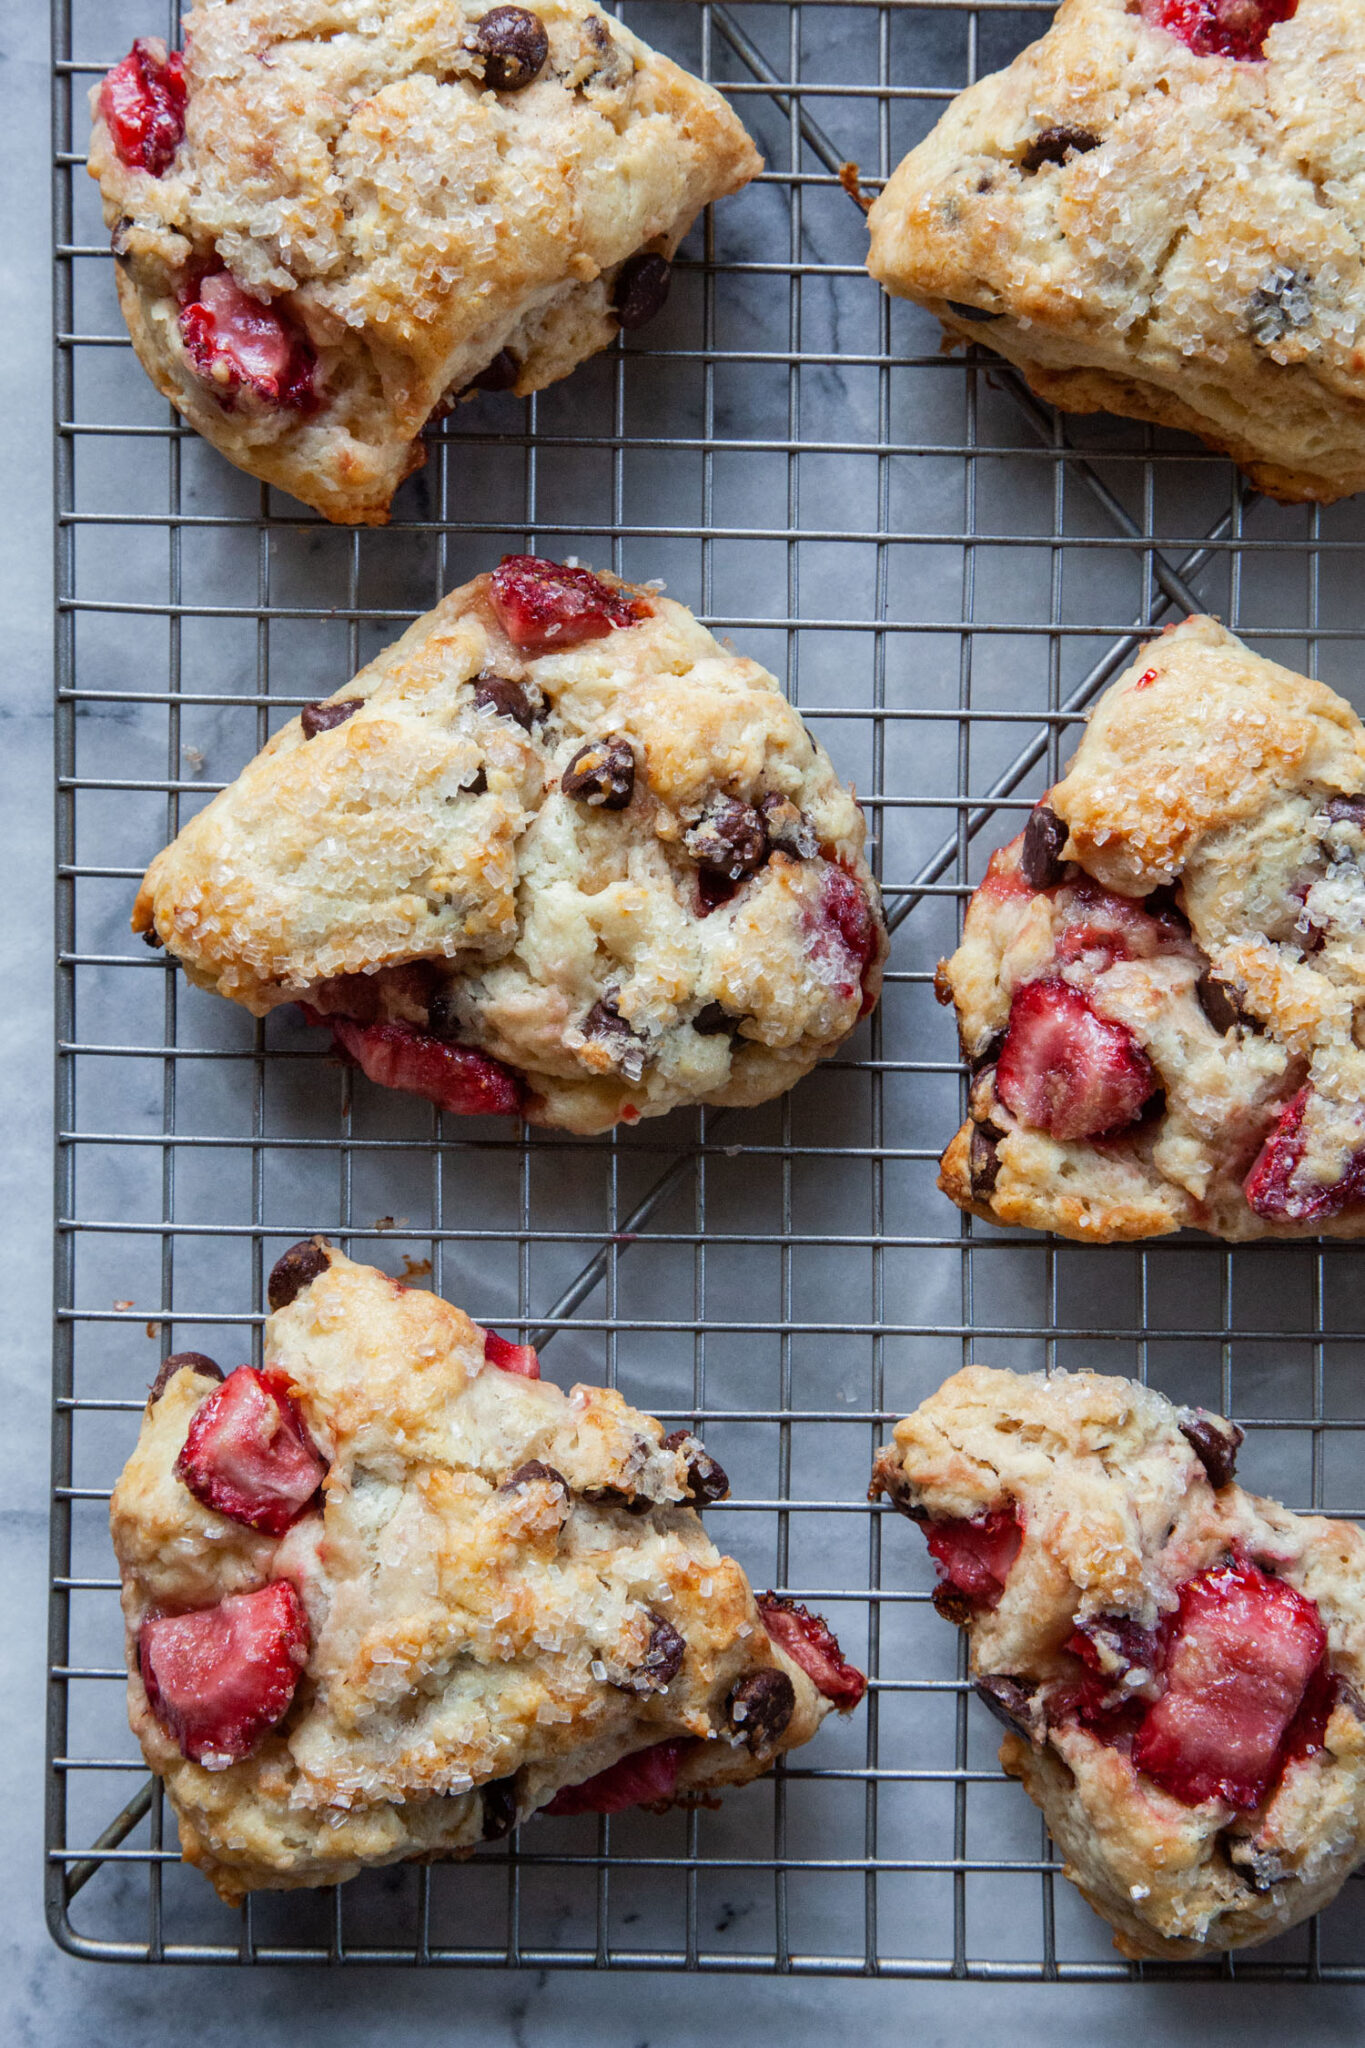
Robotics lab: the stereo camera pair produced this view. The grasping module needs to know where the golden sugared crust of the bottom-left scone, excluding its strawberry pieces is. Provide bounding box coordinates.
[111,1241,855,1903]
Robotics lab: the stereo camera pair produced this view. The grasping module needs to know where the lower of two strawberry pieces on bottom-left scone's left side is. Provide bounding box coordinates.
[137,1579,309,1772]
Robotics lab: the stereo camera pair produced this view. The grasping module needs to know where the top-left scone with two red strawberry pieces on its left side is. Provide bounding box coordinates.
[90,0,761,524]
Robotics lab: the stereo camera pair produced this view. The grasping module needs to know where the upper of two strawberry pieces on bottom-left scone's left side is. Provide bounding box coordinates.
[176,1366,327,1536]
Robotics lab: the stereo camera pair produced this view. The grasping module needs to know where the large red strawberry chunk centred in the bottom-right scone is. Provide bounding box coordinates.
[1132,1559,1326,1806]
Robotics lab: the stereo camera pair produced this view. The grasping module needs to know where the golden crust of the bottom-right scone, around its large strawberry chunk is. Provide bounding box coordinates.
[872,1366,1365,1960]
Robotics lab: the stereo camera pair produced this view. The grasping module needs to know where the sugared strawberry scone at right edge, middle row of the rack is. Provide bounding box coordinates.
[937,618,1365,1243]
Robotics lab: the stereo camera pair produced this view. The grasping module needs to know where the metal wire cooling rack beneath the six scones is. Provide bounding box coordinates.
[47,0,1365,1978]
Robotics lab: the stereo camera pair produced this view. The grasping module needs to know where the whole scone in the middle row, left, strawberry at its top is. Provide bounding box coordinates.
[133,555,886,1133]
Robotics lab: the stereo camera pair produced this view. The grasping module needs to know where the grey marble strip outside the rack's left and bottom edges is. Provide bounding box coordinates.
[0,4,1365,2048]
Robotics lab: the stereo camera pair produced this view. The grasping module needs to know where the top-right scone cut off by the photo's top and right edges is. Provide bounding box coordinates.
[870,0,1365,502]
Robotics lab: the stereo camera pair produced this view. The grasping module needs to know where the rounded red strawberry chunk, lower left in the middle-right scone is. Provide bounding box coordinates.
[995,979,1156,1139]
